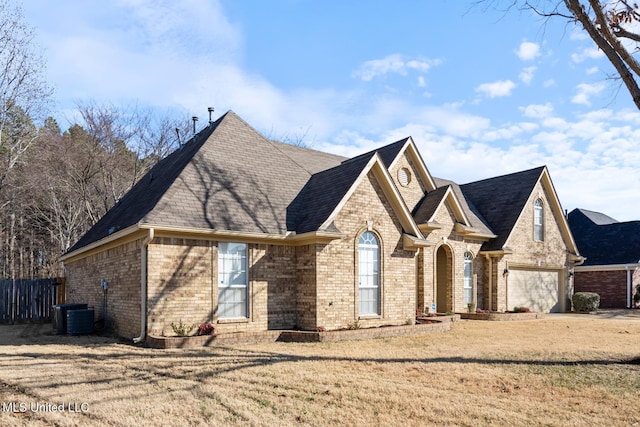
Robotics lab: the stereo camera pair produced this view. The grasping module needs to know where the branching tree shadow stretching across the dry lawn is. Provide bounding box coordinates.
[0,336,640,421]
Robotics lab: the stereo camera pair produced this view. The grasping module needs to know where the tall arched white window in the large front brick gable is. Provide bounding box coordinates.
[358,231,380,316]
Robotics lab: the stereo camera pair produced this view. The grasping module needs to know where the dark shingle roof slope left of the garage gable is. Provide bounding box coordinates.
[460,166,545,251]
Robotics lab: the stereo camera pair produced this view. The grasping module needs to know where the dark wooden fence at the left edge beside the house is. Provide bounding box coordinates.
[0,279,65,323]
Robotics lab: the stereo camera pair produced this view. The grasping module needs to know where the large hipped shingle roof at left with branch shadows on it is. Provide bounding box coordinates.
[69,112,344,252]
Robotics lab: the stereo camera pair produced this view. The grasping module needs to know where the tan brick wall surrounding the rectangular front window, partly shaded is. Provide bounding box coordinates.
[148,237,298,335]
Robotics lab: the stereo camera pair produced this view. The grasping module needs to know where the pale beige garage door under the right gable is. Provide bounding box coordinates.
[507,269,563,313]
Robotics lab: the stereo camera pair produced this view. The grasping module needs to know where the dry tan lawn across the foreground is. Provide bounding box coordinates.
[0,315,640,426]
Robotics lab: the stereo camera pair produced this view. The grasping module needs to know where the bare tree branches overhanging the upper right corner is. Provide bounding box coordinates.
[476,0,640,109]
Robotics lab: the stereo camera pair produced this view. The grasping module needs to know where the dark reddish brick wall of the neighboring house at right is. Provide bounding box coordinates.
[573,270,627,308]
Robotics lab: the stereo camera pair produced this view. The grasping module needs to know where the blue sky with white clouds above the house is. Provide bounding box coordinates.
[23,0,640,221]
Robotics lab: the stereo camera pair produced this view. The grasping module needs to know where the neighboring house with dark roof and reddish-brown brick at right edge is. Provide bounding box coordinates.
[568,209,640,308]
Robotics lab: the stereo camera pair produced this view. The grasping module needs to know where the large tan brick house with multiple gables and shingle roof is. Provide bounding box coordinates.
[63,112,581,340]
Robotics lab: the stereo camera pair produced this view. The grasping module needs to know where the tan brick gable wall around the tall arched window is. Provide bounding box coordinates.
[316,173,417,330]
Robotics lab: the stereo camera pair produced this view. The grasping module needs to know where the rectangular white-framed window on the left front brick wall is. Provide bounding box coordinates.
[218,242,249,319]
